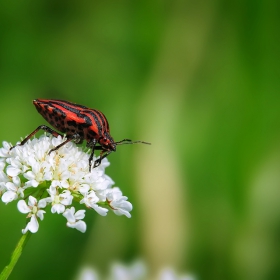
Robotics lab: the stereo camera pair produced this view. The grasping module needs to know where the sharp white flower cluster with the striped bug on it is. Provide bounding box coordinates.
[0,135,132,234]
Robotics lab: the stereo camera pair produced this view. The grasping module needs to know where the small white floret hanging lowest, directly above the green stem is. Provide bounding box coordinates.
[17,195,46,234]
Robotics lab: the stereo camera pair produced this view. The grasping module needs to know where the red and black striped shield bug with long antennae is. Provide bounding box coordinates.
[11,99,151,172]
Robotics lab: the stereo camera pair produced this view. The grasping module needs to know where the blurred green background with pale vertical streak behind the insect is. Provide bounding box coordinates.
[0,0,280,280]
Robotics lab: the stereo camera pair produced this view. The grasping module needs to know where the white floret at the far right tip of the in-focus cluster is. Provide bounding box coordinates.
[106,187,132,218]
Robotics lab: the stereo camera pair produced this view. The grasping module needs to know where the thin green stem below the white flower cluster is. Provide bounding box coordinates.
[0,231,31,280]
